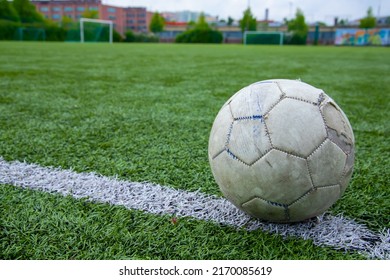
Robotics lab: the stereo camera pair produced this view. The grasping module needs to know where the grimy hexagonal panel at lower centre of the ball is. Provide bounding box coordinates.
[252,150,312,205]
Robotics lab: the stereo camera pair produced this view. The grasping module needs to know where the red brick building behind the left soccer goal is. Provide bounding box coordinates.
[31,0,149,35]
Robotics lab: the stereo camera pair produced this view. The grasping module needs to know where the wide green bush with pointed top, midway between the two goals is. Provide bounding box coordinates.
[175,13,223,44]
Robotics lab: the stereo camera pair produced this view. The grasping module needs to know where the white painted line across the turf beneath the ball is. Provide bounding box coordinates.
[0,157,390,259]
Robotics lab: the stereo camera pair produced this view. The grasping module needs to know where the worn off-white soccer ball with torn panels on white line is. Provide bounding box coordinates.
[208,79,354,223]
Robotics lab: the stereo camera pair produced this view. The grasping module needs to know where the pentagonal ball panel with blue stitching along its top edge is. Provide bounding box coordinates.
[227,118,271,165]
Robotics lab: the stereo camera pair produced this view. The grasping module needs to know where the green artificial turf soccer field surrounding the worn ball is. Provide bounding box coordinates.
[0,42,390,259]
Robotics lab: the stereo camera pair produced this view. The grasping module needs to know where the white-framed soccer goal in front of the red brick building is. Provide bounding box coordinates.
[80,18,113,43]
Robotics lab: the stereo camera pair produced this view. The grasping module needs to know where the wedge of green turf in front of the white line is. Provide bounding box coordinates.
[0,185,363,260]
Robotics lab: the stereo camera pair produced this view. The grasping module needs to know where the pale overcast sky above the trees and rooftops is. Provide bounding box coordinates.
[102,0,390,23]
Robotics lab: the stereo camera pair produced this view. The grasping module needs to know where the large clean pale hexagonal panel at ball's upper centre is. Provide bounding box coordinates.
[265,98,327,157]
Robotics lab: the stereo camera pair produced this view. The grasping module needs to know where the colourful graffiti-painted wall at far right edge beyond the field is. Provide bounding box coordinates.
[335,28,390,46]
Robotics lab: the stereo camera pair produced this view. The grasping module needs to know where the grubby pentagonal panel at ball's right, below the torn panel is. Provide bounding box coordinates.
[307,140,347,187]
